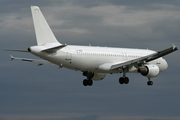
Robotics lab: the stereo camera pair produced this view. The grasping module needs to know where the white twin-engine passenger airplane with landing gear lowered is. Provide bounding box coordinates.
[5,6,178,86]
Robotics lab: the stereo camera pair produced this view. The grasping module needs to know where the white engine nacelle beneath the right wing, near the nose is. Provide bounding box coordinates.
[138,65,160,78]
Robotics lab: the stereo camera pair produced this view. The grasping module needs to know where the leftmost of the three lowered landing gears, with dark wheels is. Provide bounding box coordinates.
[83,72,94,86]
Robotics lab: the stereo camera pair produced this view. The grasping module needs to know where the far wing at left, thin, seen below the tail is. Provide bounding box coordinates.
[10,55,55,66]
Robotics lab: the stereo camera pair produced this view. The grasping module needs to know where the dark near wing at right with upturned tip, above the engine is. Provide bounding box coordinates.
[111,44,178,70]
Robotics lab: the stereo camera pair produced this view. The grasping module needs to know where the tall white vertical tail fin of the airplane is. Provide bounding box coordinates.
[31,6,60,46]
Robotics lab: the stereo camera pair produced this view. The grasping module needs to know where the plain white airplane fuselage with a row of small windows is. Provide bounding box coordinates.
[31,45,168,73]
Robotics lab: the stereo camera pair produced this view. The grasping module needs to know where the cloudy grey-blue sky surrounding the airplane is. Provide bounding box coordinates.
[0,0,180,120]
